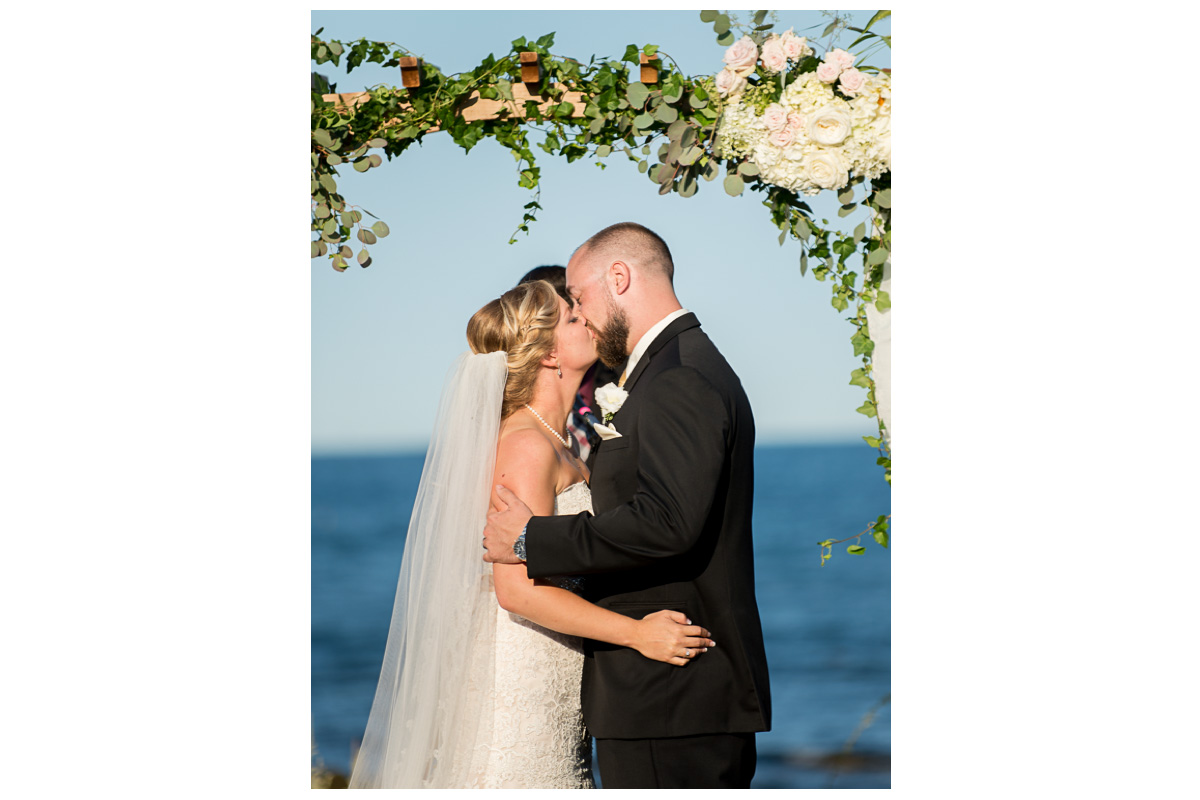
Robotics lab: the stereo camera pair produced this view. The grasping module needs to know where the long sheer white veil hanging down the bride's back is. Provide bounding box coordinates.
[350,353,508,789]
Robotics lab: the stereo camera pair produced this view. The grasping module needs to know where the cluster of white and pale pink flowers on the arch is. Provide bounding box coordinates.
[716,31,892,194]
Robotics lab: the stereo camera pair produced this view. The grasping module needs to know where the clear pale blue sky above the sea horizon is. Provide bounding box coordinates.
[312,11,890,453]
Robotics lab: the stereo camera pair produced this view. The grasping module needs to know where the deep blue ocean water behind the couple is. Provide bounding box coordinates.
[312,444,892,789]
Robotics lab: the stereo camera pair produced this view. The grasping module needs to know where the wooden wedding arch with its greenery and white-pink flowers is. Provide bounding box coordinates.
[311,11,892,563]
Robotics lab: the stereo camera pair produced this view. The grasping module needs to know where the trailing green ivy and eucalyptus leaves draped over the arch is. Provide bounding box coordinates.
[311,11,892,563]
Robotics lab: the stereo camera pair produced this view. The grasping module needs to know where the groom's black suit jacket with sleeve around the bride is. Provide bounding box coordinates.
[526,313,770,739]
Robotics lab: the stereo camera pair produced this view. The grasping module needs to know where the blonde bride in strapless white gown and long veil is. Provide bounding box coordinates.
[350,281,714,789]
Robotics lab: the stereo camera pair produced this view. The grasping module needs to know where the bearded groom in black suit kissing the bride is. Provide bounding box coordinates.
[484,222,770,789]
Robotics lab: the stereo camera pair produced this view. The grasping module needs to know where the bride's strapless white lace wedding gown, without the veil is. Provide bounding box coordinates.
[475,482,595,789]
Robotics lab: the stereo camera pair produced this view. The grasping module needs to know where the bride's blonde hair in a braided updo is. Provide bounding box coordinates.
[467,281,559,419]
